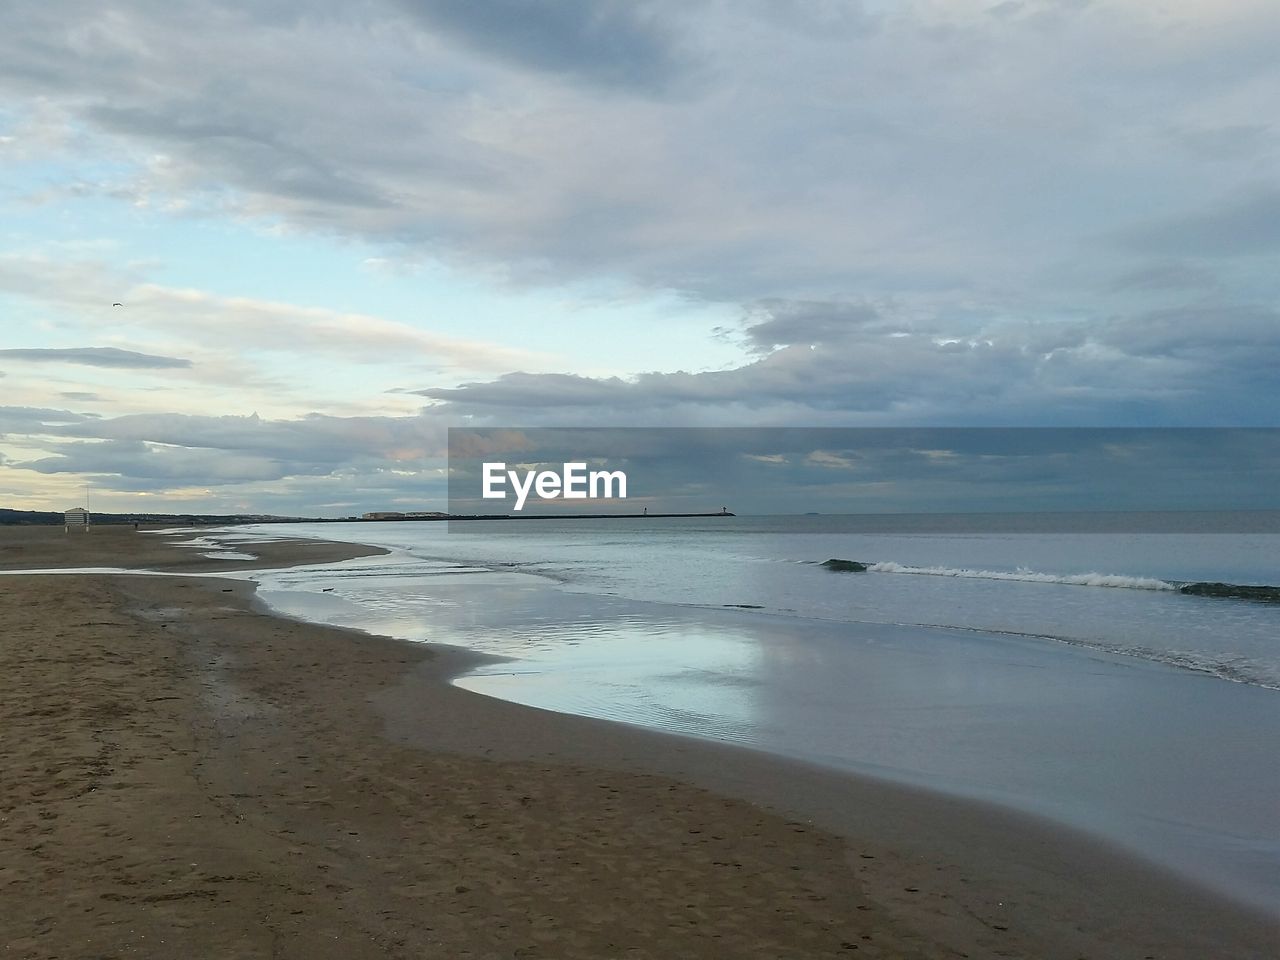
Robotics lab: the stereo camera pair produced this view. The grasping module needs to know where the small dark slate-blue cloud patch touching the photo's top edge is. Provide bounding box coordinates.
[397,0,685,90]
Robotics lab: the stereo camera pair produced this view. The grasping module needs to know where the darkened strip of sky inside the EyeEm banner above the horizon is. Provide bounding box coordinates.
[448,426,1280,519]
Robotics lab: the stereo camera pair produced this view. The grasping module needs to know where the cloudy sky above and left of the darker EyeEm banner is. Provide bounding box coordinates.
[0,0,1280,516]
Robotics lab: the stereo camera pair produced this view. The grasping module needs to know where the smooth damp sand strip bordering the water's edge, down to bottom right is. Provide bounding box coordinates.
[374,640,1280,957]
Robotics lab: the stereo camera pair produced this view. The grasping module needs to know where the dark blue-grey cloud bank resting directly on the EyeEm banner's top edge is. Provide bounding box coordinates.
[419,301,1280,426]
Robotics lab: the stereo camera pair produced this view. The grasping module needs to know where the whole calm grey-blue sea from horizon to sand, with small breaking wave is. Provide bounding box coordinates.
[212,512,1280,915]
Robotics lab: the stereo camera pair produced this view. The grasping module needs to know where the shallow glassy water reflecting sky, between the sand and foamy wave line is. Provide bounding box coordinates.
[247,530,1280,918]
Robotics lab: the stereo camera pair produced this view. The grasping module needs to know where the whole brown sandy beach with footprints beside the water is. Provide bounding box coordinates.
[0,527,1280,960]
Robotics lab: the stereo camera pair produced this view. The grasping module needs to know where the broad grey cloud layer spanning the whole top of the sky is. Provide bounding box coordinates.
[0,0,1280,303]
